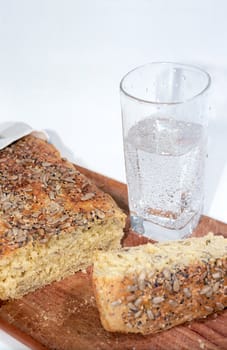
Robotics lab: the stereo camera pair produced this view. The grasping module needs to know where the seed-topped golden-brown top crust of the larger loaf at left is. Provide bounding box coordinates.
[0,135,125,259]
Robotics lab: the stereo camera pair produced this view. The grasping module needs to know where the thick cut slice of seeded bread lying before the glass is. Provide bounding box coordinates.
[93,234,227,334]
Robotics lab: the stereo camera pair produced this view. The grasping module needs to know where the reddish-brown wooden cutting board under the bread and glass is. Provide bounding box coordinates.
[0,167,227,350]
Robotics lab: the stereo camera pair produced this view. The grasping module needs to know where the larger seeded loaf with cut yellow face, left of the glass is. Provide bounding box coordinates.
[0,135,125,300]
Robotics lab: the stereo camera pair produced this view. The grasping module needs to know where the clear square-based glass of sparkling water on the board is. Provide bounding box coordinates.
[120,62,211,241]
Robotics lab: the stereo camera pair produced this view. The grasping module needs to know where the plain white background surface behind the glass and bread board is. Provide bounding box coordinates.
[0,0,227,350]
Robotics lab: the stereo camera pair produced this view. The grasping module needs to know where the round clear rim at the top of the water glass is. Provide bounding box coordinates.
[120,61,211,105]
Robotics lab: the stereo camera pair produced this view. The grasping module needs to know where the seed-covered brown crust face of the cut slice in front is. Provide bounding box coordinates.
[93,238,227,334]
